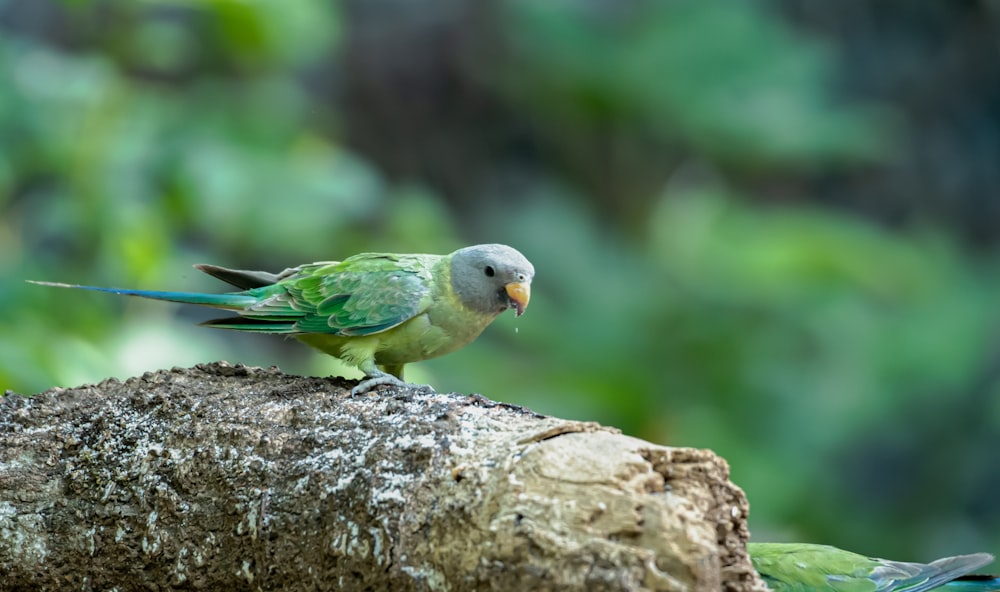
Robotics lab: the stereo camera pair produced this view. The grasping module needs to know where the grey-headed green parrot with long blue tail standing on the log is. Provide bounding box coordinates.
[34,244,535,394]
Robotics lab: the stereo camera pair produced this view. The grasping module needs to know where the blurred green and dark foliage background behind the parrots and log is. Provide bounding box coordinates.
[0,0,1000,560]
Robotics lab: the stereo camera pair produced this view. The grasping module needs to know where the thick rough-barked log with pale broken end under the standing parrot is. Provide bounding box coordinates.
[0,363,762,591]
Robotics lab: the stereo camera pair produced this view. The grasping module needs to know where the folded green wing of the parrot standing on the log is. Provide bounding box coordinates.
[206,253,433,336]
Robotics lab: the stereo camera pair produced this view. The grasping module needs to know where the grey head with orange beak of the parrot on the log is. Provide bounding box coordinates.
[451,245,535,316]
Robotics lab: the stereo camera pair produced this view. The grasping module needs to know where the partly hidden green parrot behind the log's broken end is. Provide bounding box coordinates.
[747,543,1000,592]
